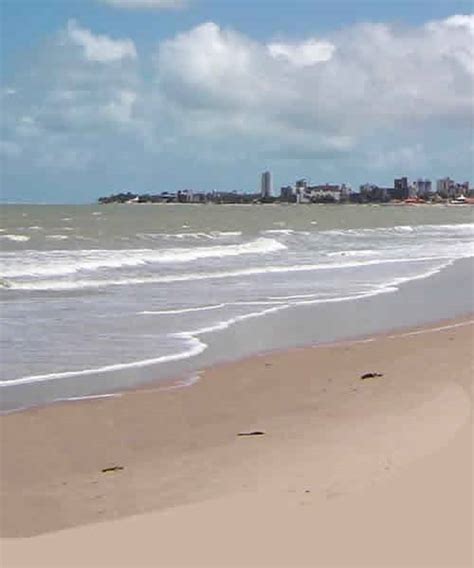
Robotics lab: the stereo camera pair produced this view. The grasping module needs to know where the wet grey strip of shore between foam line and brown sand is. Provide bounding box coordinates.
[0,255,473,415]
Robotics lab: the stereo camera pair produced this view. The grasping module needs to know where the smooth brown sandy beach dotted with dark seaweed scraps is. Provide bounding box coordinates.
[0,320,473,567]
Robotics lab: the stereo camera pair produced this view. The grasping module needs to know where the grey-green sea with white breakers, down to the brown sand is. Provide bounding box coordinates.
[0,204,474,411]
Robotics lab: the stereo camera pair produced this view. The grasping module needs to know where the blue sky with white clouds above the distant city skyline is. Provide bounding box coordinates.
[0,0,474,203]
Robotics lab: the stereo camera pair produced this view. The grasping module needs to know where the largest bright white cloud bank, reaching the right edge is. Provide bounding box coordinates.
[156,16,474,142]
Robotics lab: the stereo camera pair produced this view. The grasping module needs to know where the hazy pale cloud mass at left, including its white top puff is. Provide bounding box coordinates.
[2,21,144,172]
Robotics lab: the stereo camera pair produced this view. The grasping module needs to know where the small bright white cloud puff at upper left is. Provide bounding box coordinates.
[66,20,137,63]
